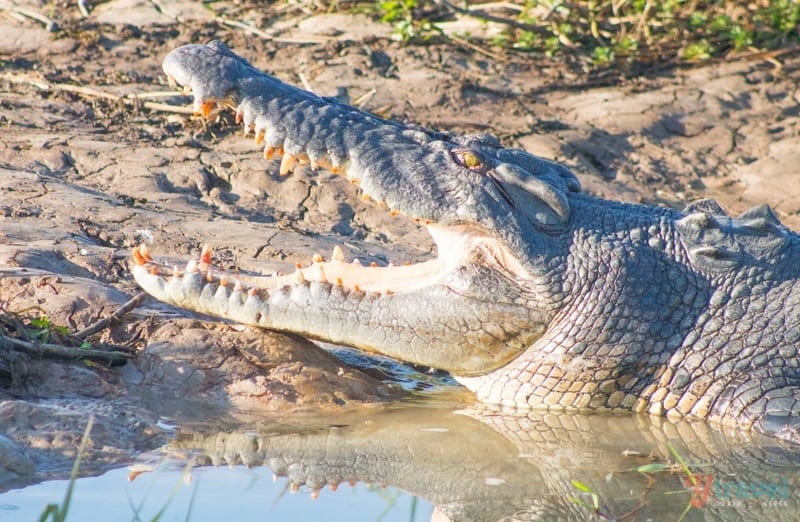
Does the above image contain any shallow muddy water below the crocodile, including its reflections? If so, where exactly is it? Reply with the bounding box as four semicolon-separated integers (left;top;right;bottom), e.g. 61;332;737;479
0;404;800;521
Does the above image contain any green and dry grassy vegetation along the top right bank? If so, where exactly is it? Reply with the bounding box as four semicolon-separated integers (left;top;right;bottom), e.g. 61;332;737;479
354;0;800;68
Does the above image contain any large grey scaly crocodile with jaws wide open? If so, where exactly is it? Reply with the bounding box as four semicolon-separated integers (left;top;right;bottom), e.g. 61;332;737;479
132;41;800;442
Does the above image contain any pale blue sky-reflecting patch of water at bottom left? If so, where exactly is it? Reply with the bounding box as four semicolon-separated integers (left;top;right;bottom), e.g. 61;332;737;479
0;466;433;522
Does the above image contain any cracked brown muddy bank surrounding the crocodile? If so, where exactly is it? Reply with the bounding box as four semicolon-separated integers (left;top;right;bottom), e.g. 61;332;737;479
0;0;800;489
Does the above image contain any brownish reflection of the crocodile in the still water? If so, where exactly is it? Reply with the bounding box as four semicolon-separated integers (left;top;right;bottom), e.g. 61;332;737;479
172;406;800;521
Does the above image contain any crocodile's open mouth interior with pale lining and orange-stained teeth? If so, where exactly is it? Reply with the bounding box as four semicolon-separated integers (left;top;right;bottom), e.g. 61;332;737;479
134;68;526;294
